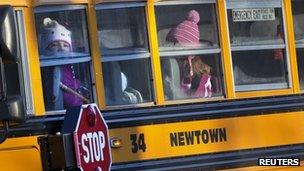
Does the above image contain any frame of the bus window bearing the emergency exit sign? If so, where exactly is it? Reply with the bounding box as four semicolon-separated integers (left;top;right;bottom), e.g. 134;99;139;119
226;0;293;93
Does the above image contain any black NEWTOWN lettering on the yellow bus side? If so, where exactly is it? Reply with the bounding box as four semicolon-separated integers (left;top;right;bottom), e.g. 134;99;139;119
170;128;227;147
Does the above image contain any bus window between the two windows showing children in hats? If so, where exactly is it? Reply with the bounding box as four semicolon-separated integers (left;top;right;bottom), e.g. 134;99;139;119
96;3;153;106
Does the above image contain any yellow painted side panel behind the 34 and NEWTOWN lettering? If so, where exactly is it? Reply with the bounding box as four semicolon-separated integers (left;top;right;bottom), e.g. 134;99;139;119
110;112;304;162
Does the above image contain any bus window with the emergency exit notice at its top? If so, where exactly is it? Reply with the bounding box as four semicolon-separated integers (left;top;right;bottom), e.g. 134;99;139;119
227;0;289;91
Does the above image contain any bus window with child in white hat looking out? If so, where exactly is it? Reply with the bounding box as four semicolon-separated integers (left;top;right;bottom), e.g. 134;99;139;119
35;6;92;111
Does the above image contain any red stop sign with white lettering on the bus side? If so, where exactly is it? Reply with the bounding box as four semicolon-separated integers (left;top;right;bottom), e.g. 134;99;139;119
74;104;112;171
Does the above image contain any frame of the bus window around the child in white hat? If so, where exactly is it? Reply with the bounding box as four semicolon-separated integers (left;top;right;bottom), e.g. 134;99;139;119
33;3;97;115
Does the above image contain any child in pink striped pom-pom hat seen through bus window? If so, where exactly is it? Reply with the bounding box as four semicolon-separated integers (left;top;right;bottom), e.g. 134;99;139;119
166;10;212;97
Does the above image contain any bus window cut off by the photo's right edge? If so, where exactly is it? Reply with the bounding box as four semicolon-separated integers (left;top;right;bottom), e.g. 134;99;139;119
292;0;304;90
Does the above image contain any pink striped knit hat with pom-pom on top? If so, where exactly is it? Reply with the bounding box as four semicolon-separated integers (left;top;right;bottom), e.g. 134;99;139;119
167;10;200;46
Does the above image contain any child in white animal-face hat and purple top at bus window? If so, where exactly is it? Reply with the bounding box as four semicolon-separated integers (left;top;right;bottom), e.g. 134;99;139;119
41;18;89;110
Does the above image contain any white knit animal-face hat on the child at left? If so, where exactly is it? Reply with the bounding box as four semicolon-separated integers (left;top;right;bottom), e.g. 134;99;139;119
41;18;72;51
